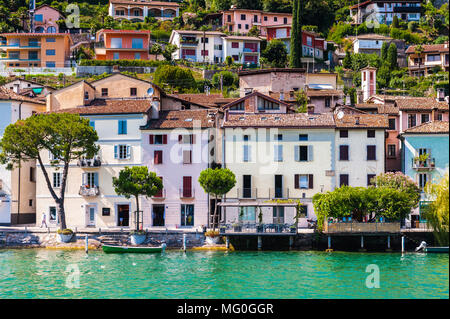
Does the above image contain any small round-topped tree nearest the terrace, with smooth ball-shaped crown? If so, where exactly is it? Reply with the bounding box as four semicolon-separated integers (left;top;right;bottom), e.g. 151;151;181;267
198;168;236;230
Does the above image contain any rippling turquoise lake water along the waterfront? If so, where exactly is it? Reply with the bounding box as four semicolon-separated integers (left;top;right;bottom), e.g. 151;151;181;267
0;249;449;299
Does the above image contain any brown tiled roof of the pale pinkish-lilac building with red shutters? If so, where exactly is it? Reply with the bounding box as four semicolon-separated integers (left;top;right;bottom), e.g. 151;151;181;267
141;110;217;130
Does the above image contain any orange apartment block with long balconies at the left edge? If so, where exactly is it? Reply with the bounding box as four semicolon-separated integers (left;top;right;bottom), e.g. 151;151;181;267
0;33;72;68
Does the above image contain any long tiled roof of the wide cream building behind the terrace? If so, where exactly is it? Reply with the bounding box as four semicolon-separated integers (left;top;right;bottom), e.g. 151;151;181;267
222;113;335;128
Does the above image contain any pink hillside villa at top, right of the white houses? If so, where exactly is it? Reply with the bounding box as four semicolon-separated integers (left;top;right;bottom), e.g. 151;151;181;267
222;8;292;36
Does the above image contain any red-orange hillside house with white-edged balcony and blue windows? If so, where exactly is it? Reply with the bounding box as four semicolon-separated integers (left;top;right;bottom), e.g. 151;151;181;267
95;29;150;60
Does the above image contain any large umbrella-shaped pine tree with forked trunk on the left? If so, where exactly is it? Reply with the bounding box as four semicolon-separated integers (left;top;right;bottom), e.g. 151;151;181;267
0;113;99;230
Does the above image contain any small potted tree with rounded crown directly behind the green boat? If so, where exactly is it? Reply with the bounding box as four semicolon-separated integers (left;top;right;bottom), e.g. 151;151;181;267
113;166;163;231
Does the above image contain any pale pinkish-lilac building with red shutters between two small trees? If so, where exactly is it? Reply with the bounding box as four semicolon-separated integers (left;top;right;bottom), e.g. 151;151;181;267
141;109;217;229
